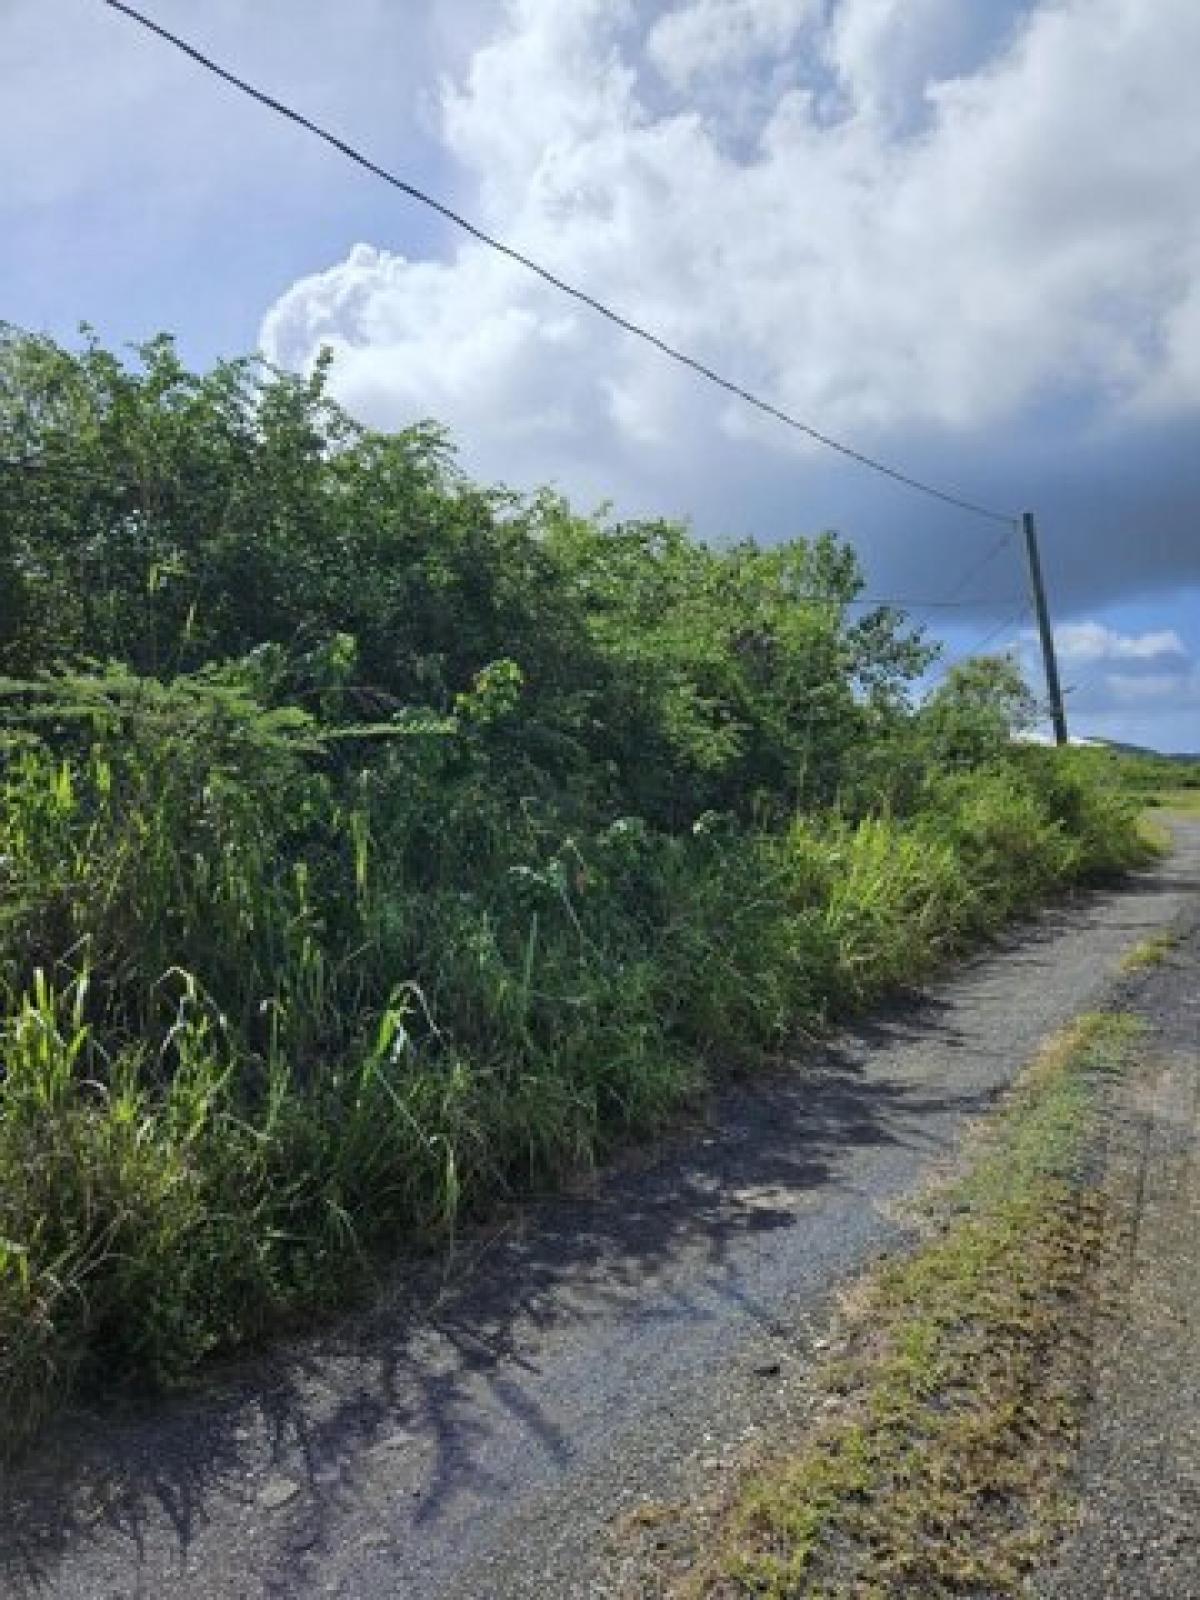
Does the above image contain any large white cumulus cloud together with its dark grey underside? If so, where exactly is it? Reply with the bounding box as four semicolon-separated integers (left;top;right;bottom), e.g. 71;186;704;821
261;0;1200;600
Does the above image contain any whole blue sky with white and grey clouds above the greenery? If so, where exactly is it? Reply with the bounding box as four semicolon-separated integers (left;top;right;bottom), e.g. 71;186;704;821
0;0;1200;750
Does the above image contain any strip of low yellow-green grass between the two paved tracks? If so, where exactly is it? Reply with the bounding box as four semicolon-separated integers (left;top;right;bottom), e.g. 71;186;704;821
690;1014;1138;1600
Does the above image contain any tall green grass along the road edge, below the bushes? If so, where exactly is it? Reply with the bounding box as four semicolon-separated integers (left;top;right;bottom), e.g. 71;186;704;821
0;685;1139;1445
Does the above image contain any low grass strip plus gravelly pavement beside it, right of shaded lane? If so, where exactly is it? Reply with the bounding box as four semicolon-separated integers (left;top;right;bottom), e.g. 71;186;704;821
614;926;1200;1600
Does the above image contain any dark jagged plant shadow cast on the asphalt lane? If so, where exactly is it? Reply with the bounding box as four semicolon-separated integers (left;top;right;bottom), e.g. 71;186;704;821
0;851;1194;1595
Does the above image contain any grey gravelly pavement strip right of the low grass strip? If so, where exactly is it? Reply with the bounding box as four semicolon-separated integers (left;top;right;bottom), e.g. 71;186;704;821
1035;931;1200;1600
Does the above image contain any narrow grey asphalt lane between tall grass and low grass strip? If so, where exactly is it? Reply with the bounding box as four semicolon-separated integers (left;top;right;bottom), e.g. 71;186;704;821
0;822;1200;1600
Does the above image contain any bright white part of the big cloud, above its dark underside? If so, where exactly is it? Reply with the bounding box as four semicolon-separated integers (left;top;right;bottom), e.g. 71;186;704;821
262;0;1200;472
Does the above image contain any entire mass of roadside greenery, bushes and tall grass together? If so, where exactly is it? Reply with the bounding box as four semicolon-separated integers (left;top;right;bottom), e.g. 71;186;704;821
0;330;1146;1443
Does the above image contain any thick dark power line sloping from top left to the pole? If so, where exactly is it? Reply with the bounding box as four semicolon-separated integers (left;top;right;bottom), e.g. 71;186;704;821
104;0;1016;523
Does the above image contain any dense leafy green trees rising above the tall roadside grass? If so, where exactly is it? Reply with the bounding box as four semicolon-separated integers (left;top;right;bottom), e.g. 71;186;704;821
0;328;930;829
